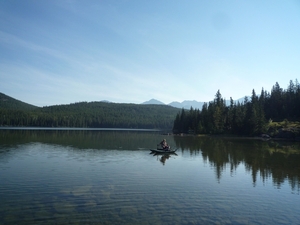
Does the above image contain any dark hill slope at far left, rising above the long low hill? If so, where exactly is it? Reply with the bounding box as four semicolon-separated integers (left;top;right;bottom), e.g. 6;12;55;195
0;92;38;110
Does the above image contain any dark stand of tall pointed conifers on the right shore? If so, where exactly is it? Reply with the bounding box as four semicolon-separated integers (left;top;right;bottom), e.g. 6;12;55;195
173;79;300;135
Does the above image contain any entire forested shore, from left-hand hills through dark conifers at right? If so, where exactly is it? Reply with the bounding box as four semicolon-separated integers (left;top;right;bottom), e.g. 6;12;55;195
0;80;300;135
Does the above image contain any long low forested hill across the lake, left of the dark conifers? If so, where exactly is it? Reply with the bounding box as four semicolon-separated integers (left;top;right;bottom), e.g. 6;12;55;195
0;102;178;130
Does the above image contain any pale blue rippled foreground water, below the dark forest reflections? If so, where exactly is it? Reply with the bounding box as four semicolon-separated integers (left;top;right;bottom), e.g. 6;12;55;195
0;139;300;224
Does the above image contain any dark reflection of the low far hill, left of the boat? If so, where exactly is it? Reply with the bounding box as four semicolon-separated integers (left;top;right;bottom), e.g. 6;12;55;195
0;130;166;150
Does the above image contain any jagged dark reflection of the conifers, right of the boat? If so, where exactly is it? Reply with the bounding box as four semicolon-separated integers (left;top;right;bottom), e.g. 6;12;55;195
174;136;300;190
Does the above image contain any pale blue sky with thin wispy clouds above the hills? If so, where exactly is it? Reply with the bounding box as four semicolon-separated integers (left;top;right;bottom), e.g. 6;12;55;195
0;0;300;106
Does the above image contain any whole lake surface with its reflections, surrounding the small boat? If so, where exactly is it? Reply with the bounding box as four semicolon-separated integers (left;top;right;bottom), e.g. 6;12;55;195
0;130;300;224
